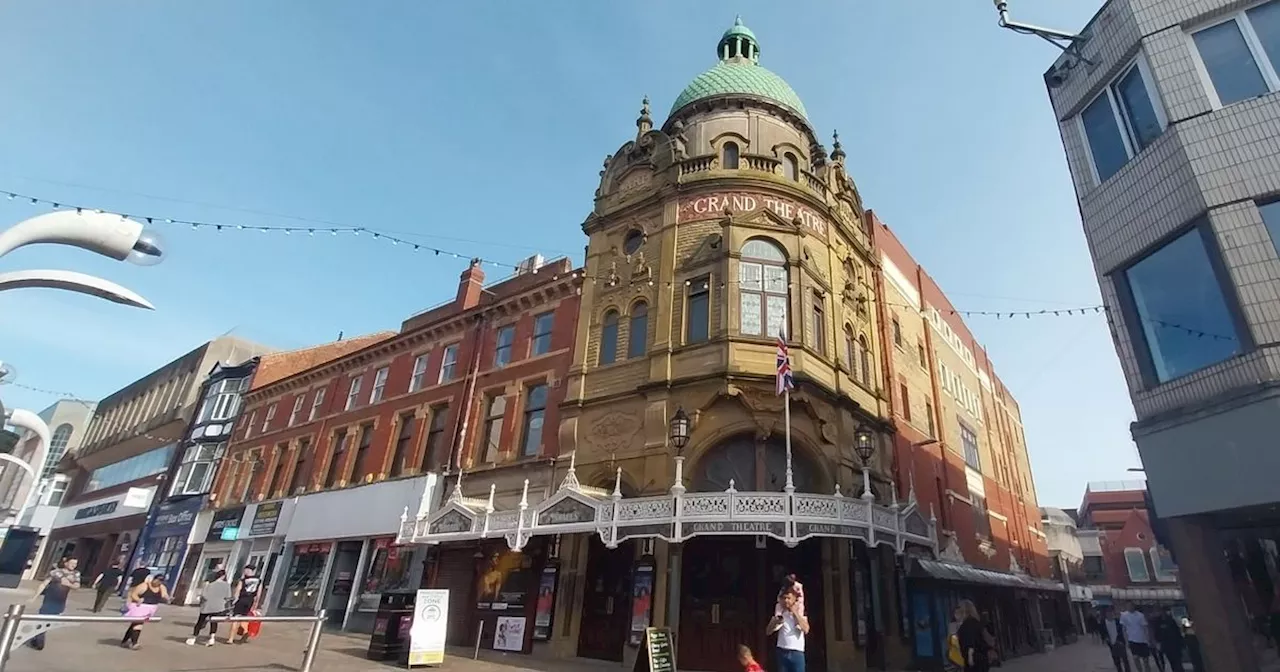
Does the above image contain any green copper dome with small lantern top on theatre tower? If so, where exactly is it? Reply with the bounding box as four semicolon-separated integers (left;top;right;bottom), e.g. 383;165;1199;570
671;18;808;118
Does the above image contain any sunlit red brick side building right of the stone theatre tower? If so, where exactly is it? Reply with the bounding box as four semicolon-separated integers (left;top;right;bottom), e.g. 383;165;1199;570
868;212;1069;657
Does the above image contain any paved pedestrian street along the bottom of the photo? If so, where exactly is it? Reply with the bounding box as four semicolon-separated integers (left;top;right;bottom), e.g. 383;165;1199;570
0;581;1146;672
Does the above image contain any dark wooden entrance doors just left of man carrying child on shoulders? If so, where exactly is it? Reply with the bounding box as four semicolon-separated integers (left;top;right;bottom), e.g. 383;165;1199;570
676;536;757;672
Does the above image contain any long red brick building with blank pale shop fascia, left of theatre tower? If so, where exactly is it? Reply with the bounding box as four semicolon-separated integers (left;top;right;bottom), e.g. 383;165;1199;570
214;257;581;630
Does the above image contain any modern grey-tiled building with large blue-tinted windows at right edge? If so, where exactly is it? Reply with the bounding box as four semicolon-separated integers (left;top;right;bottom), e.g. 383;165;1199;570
1044;0;1280;672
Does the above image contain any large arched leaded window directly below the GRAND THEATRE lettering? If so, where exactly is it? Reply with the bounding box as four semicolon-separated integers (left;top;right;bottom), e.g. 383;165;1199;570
737;238;787;337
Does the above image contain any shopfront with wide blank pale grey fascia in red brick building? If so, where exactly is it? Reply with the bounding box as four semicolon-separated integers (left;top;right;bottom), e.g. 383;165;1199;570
274;474;436;632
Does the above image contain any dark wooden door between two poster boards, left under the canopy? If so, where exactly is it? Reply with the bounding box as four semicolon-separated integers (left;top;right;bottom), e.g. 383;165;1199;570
577;534;635;663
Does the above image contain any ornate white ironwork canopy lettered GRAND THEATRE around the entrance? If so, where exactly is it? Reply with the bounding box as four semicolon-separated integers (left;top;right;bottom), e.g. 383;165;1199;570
397;453;937;553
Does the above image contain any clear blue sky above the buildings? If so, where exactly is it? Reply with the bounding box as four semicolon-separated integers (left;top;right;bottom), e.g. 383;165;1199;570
0;0;1138;506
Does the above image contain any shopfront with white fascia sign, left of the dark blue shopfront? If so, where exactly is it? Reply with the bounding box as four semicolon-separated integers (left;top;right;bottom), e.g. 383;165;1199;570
42;485;156;581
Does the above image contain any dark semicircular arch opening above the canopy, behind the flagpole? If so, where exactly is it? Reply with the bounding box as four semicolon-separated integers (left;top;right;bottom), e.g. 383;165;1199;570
690;434;829;493
